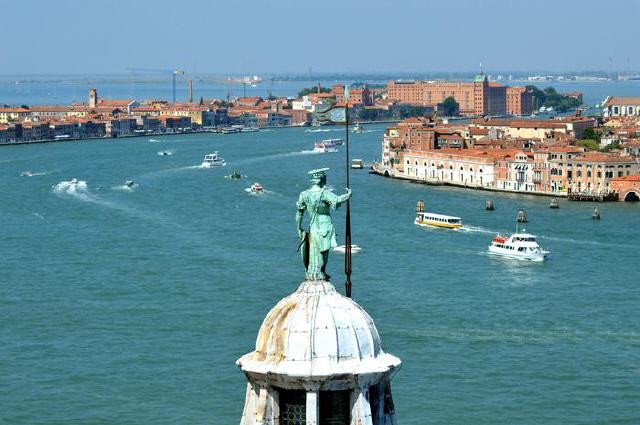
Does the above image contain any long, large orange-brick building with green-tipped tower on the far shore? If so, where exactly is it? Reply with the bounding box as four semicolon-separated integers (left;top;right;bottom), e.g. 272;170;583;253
387;75;507;116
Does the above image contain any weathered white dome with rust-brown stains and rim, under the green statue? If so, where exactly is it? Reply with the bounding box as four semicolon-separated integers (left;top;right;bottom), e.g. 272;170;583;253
237;281;401;378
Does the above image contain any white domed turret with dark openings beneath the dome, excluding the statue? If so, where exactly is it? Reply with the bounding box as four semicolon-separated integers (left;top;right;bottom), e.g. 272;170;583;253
236;280;401;425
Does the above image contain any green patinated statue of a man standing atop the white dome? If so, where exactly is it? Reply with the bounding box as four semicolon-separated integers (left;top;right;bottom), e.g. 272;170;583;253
296;168;351;280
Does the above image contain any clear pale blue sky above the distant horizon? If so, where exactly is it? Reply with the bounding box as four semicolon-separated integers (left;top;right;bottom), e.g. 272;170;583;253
0;0;640;74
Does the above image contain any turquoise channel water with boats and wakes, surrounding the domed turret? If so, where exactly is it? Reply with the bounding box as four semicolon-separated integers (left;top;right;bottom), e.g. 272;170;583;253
0;126;640;425
